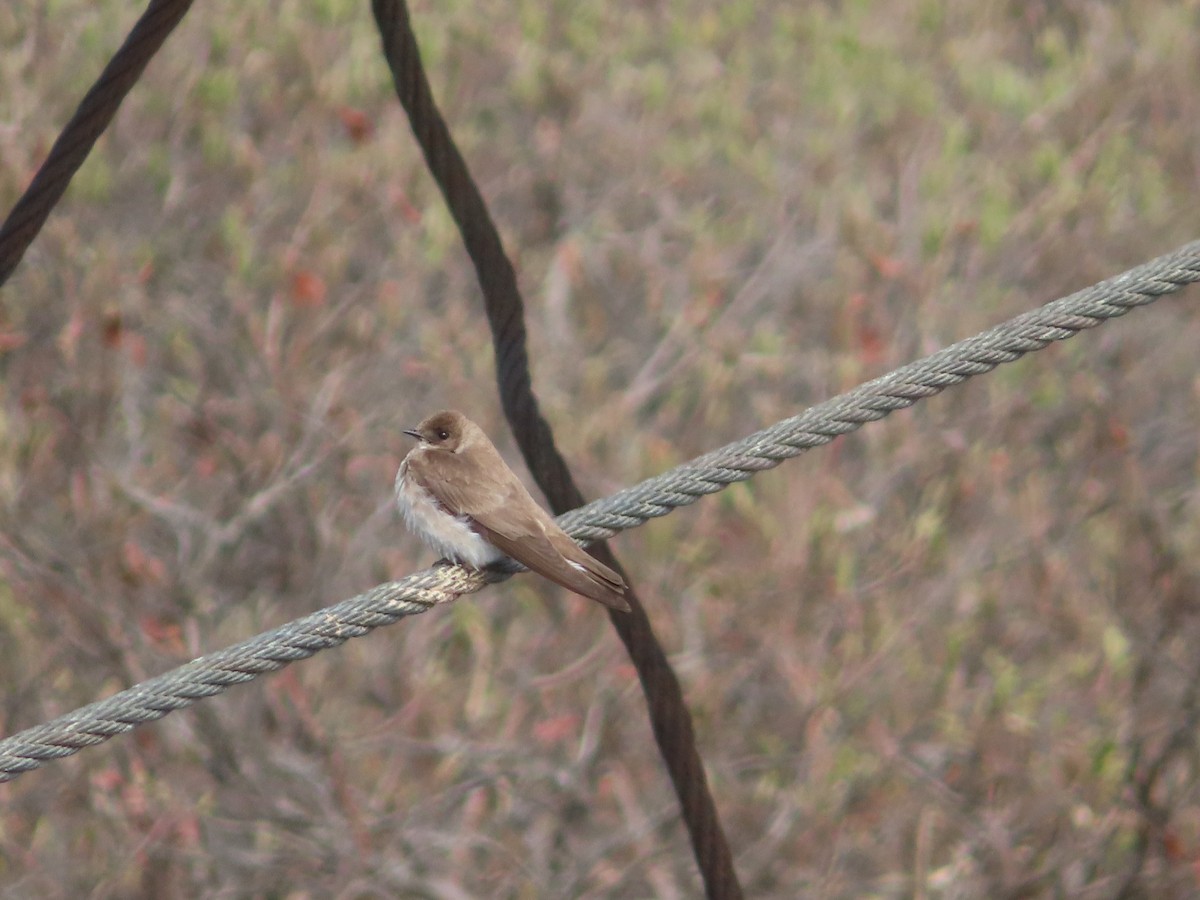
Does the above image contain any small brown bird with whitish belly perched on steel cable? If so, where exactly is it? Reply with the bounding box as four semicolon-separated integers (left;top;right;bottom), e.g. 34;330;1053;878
396;409;629;612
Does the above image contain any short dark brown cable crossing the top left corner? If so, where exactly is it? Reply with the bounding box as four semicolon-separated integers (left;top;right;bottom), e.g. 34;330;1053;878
0;0;192;284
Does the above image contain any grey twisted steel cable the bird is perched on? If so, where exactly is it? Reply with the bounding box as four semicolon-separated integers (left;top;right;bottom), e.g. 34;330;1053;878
0;241;1200;781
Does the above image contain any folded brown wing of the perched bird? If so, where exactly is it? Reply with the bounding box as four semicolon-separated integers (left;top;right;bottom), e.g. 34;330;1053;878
425;455;629;612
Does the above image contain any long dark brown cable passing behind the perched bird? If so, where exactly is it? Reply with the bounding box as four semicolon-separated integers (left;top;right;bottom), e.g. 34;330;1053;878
371;0;742;900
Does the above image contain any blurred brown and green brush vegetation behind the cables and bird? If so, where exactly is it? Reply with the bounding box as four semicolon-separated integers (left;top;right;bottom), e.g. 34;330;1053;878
0;0;1200;899
